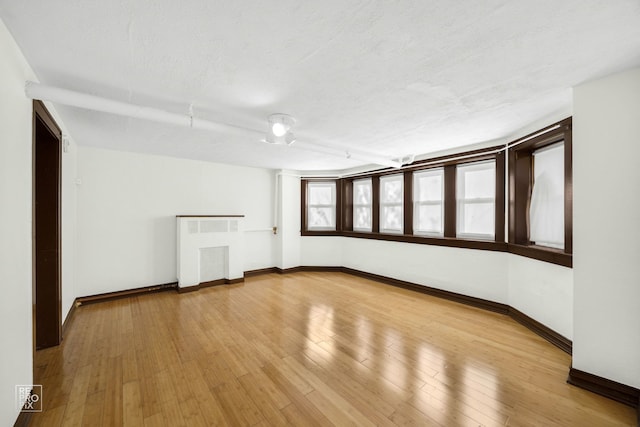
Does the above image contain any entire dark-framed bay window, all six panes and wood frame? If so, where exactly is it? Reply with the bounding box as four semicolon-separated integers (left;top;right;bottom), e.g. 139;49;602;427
301;118;572;267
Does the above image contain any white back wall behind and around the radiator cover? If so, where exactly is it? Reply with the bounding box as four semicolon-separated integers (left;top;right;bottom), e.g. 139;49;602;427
76;146;275;296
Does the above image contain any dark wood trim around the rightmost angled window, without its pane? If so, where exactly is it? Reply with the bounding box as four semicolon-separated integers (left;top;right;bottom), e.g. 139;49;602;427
508;118;573;267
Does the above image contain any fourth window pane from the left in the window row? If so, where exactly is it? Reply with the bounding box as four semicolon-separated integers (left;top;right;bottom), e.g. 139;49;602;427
413;168;444;236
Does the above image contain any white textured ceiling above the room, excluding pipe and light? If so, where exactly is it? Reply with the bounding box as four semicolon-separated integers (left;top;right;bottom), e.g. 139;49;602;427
0;0;640;170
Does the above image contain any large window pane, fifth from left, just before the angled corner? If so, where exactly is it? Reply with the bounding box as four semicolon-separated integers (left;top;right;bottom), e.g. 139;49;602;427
456;160;496;239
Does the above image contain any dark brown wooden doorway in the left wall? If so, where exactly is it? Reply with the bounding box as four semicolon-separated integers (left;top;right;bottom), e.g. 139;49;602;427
33;101;62;350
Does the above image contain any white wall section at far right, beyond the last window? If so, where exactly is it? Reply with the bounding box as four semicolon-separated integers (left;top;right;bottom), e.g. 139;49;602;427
573;69;640;388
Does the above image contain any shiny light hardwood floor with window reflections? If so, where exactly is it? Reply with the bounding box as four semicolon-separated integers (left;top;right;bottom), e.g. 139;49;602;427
31;273;636;427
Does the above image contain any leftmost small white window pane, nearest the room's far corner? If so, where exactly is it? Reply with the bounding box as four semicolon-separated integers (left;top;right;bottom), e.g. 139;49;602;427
307;181;336;231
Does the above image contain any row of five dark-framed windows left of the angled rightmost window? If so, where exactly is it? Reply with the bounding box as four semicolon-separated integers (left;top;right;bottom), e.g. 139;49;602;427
300;145;509;251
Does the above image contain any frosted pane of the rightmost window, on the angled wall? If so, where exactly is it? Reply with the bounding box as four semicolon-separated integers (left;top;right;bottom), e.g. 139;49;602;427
529;144;564;249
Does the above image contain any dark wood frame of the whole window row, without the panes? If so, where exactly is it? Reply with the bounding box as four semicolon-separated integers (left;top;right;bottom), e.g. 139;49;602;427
301;117;573;268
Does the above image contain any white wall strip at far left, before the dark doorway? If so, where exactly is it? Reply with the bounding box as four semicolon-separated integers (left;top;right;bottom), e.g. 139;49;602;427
0;16;33;425
